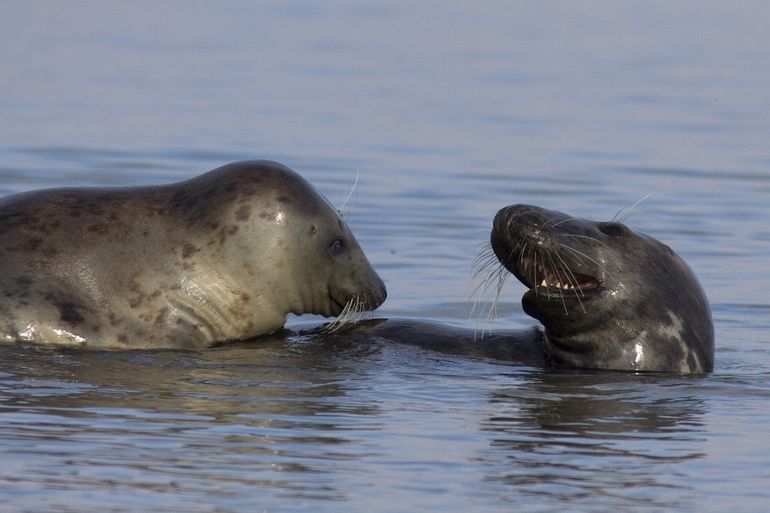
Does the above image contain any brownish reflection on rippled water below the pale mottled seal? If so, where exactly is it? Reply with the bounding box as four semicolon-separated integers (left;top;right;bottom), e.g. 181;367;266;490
0;341;388;506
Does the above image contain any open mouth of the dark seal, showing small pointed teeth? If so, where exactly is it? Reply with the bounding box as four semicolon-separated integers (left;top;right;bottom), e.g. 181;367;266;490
514;257;601;297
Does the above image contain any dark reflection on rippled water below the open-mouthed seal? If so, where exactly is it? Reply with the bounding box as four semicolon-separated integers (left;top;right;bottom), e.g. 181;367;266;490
481;372;705;511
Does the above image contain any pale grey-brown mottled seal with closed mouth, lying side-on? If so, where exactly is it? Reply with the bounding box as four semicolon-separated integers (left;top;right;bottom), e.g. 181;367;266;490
0;161;385;348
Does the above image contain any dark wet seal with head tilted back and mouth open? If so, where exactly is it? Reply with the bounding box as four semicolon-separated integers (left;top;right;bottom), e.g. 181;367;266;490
316;205;714;374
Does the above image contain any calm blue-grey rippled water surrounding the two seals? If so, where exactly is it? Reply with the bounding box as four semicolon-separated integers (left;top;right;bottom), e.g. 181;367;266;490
0;0;770;513
